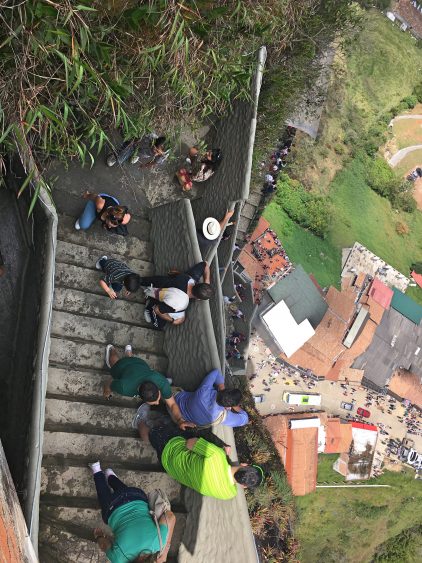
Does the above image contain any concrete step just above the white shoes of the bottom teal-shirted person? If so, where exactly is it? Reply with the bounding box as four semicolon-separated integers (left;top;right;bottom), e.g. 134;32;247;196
43;430;158;468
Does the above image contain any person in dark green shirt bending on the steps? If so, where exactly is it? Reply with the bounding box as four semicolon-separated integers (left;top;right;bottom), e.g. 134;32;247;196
103;344;195;430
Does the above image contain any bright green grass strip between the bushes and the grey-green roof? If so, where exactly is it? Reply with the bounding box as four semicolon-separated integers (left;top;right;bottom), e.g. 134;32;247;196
264;202;341;287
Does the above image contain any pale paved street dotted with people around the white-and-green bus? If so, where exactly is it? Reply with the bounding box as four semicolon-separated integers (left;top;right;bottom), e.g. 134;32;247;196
248;335;422;476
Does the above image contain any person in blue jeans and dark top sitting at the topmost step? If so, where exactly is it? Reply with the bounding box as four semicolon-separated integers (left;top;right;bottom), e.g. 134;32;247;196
75;191;131;236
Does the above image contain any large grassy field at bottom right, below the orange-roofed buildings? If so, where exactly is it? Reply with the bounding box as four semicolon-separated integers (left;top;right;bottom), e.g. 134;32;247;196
296;472;422;563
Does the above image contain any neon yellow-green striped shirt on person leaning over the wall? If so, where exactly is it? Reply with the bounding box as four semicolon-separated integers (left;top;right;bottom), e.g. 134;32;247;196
161;436;237;500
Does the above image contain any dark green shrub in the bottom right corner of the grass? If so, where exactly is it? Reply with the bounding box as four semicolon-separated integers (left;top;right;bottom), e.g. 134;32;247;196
371;525;422;563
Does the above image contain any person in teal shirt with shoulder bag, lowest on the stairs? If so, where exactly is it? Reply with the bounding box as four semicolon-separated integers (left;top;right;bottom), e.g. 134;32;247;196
90;461;176;563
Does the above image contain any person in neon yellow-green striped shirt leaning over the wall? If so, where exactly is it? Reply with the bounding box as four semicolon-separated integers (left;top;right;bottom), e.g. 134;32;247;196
138;420;264;500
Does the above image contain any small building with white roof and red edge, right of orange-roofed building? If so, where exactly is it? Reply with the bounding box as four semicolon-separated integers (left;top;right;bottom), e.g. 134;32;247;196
333;422;378;481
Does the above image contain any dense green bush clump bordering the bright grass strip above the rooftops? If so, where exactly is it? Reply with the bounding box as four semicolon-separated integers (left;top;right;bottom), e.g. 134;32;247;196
275;174;331;238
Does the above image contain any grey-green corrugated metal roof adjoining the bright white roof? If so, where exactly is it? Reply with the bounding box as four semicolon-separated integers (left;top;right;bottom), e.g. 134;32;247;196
268;264;328;328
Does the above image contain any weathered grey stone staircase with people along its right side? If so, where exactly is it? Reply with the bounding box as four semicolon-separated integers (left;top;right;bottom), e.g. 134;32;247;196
39;215;186;563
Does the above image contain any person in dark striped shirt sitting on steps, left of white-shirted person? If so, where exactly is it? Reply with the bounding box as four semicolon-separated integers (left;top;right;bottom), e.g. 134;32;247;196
95;256;140;299
